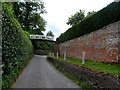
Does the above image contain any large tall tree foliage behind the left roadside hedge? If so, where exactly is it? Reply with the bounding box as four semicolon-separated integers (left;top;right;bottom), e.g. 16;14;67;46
13;0;46;35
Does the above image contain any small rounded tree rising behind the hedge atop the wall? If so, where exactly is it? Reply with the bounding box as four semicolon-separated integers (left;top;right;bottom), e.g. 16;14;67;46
67;10;85;26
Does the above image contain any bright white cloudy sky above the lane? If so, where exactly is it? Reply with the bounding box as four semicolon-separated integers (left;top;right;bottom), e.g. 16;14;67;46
42;0;114;40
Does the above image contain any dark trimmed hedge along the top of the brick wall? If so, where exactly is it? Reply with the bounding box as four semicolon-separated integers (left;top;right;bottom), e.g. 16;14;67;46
57;2;120;43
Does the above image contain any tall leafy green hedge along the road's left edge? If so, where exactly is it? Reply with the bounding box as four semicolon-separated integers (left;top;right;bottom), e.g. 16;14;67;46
2;3;33;90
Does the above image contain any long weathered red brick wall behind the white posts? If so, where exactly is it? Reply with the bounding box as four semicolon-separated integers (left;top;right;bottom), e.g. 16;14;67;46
55;21;120;62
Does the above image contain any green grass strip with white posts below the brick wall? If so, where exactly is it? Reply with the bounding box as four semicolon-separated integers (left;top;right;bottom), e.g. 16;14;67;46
48;57;120;76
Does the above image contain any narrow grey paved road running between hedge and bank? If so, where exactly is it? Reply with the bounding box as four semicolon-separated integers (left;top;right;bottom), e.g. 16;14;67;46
12;55;80;88
